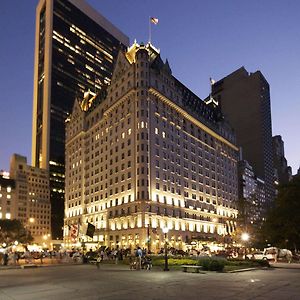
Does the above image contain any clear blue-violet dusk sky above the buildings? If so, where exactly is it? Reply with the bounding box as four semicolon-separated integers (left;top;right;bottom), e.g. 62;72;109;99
0;0;300;173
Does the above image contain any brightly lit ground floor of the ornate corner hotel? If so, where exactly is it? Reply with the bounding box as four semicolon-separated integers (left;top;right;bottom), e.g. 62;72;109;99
63;218;236;253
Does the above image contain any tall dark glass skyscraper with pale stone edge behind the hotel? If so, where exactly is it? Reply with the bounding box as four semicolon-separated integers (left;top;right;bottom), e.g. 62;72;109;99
32;0;129;238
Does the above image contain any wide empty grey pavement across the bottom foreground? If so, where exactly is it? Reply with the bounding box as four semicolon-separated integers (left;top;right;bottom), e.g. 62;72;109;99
0;265;300;300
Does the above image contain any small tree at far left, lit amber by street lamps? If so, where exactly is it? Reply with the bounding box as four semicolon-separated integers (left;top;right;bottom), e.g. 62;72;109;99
0;220;33;246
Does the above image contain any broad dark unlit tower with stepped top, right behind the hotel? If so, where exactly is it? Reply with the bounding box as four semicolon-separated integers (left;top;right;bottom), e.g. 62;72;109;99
212;67;275;207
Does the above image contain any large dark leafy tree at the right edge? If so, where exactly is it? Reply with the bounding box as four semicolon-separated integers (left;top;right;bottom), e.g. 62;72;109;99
262;176;300;249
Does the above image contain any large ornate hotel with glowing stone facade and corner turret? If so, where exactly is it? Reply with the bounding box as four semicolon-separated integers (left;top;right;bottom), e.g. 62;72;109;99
64;43;238;252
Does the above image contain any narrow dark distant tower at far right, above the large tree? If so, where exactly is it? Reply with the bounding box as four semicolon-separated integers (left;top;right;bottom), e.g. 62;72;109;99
273;135;292;184
